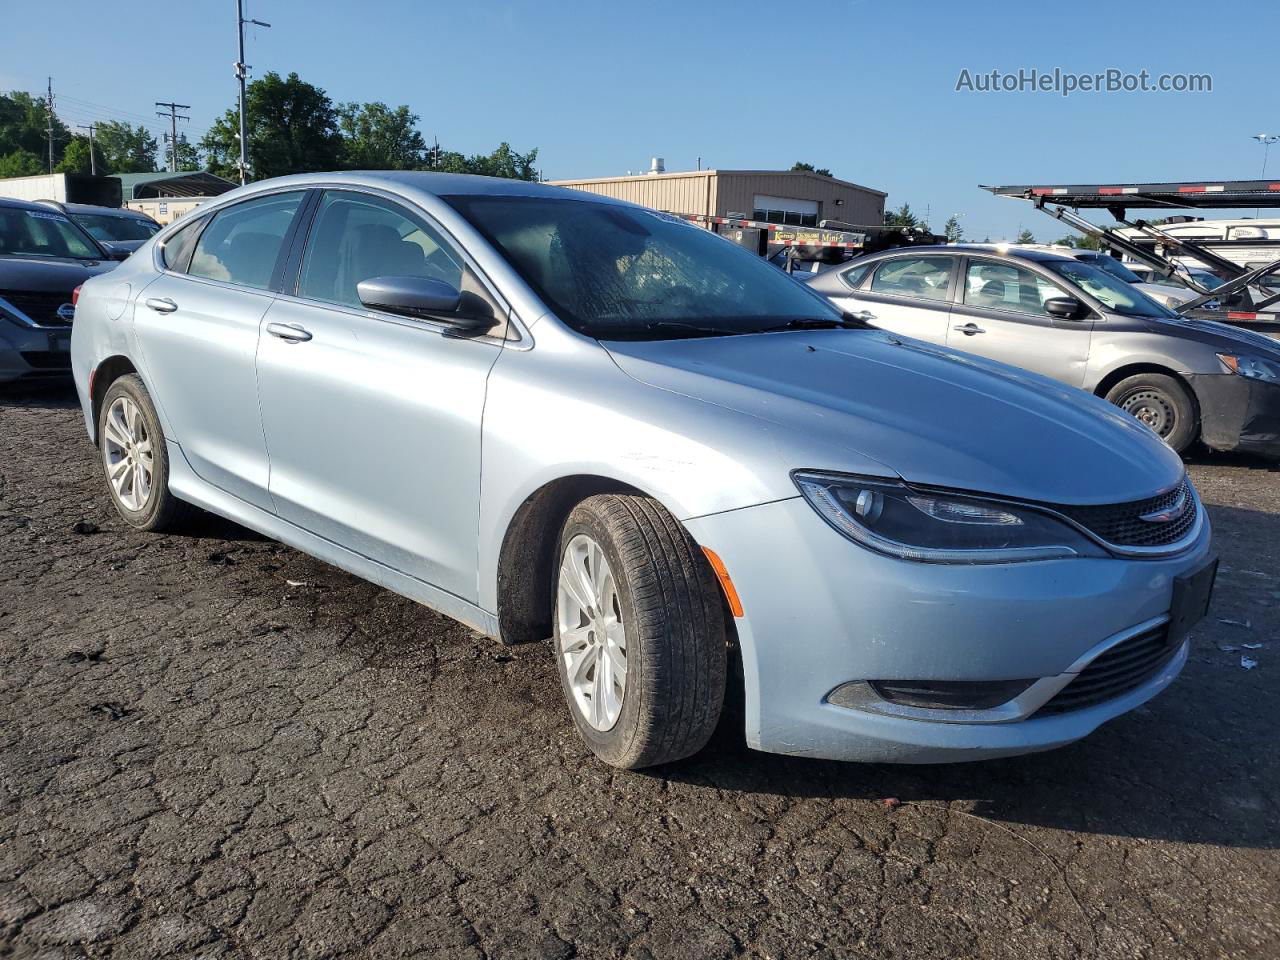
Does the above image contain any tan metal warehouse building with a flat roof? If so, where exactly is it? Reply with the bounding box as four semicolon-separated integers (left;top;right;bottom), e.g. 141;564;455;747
552;168;887;227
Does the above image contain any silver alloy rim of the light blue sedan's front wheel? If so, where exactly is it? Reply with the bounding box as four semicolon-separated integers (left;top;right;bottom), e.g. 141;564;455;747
556;534;627;731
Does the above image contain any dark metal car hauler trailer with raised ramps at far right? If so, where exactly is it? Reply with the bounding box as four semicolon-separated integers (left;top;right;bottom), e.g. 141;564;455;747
983;180;1280;337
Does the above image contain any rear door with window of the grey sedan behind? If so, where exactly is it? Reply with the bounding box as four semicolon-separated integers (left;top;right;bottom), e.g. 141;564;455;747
827;253;956;343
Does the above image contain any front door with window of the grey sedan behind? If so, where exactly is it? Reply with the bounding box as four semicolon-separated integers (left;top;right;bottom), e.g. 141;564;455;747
947;257;1096;387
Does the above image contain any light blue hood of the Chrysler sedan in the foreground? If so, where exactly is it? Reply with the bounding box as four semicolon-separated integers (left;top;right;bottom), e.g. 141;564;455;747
604;330;1184;504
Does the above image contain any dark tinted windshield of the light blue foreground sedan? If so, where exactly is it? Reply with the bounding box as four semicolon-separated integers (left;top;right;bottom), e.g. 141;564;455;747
444;196;841;339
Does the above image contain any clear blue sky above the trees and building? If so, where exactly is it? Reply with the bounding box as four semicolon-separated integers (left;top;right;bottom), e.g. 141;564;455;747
0;0;1280;239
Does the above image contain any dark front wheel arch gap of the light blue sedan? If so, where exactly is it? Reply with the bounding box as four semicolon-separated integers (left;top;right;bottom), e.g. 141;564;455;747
497;474;650;644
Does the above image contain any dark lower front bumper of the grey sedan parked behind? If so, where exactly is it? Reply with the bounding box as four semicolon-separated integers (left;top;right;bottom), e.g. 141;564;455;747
1187;374;1280;458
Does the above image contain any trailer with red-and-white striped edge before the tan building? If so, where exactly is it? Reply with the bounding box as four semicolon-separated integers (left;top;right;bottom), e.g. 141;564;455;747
675;212;946;273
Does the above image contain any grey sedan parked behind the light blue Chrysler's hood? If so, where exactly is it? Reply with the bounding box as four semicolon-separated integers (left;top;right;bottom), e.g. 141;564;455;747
809;243;1280;457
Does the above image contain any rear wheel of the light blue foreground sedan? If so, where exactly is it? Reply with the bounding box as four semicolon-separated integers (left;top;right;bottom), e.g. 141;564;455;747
97;374;196;532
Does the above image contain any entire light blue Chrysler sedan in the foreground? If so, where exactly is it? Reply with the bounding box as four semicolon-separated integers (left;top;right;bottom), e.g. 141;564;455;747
72;173;1215;767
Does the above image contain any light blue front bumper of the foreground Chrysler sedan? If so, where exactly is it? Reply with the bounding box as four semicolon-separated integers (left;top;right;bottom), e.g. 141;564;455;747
686;498;1211;763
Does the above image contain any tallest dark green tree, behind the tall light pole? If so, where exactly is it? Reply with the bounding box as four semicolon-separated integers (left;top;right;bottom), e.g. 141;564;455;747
200;72;343;179
